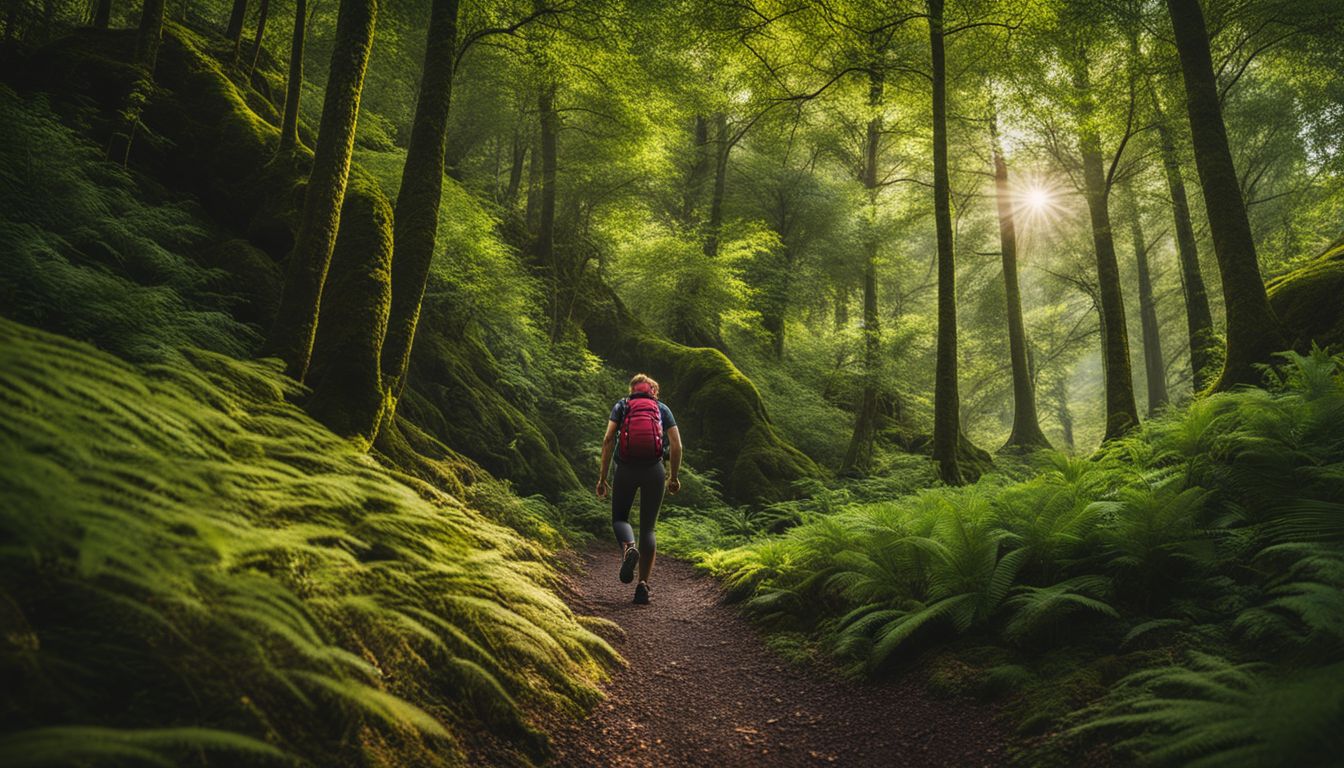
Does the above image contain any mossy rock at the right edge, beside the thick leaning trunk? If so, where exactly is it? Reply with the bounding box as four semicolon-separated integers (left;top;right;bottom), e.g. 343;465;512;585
1267;241;1344;351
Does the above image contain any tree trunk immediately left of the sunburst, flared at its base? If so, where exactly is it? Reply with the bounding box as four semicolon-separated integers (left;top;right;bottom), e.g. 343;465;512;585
989;116;1050;451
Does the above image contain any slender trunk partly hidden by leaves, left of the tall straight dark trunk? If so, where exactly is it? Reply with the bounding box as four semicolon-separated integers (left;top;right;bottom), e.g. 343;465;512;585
837;63;883;473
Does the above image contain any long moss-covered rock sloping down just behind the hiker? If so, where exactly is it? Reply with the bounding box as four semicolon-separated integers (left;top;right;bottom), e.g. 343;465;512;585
578;277;821;503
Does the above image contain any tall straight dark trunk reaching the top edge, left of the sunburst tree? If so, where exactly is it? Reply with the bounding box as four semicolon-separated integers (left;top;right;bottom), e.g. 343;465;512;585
929;0;988;486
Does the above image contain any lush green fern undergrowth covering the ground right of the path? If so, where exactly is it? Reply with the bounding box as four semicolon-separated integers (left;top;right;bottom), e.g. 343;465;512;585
688;350;1344;765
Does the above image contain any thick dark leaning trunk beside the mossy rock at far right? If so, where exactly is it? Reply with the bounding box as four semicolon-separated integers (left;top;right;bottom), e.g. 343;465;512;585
1167;0;1288;390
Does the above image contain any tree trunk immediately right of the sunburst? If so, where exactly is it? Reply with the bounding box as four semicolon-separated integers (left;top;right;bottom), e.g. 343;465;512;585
1074;62;1138;440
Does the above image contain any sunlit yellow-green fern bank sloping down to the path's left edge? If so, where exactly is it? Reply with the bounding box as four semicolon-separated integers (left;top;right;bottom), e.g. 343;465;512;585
0;321;614;765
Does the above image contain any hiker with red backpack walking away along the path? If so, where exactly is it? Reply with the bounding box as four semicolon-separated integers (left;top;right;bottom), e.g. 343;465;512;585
597;374;681;605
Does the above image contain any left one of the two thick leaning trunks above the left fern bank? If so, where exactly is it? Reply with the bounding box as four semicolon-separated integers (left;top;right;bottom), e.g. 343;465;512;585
269;0;378;381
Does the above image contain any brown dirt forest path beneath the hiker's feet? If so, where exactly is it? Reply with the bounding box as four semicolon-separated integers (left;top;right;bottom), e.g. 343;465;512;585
547;545;1004;768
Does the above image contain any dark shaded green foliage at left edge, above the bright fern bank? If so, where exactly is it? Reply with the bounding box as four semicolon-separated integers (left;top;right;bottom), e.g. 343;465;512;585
0;86;257;360
